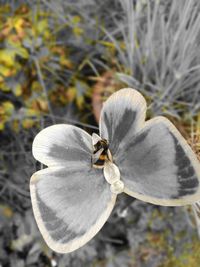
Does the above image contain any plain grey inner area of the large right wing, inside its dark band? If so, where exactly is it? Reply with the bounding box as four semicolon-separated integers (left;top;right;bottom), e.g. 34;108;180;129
116;123;177;198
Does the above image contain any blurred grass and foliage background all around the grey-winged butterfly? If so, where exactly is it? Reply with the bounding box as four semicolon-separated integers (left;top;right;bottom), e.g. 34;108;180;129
0;0;200;267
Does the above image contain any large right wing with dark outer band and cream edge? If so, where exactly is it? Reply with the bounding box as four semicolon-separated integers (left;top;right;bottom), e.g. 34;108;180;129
114;117;200;206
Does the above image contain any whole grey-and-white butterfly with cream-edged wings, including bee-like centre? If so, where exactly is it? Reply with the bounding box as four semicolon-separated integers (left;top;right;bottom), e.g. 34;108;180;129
30;88;200;253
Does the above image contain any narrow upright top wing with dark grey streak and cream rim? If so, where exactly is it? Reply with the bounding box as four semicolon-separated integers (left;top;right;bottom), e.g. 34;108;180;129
99;88;147;155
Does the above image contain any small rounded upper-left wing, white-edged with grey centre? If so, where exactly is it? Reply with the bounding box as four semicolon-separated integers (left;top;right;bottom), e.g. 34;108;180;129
32;124;92;167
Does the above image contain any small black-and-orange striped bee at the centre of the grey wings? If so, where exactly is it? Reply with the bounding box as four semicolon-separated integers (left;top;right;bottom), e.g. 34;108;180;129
92;133;112;169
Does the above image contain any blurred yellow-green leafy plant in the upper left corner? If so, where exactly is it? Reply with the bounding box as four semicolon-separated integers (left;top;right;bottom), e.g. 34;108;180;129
0;4;91;130
